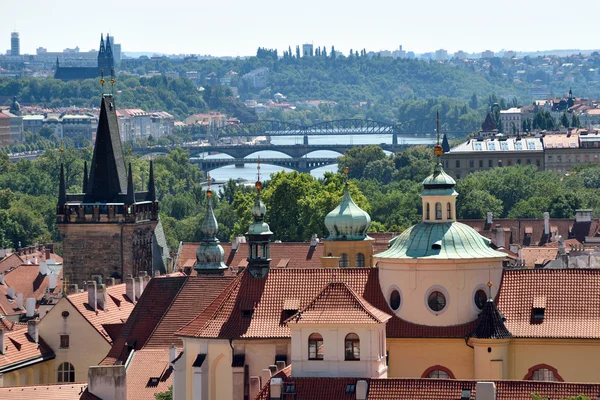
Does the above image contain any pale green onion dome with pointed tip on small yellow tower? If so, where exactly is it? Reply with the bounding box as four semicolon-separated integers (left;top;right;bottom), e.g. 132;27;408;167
325;184;371;240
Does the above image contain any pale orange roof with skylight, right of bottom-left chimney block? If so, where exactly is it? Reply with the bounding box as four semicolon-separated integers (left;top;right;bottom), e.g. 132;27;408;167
127;348;173;400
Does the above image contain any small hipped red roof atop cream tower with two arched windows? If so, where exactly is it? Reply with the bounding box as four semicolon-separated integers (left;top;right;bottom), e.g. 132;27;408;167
286;282;391;324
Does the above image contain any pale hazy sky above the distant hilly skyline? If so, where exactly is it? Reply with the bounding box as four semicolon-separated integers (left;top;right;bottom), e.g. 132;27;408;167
0;0;600;56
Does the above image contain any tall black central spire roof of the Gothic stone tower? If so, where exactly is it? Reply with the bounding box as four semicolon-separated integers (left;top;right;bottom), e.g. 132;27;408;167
85;95;127;203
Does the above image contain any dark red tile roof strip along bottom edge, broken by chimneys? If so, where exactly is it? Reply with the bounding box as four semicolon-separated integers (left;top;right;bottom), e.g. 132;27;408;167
256;372;600;400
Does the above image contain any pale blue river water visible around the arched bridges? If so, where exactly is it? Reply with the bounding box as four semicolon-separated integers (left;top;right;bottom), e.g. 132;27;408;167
197;135;435;182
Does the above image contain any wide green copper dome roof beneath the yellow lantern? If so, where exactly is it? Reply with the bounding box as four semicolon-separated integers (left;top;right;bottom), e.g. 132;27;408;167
373;222;506;260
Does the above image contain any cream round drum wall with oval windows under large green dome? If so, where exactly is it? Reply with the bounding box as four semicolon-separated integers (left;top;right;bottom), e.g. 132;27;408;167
378;259;502;326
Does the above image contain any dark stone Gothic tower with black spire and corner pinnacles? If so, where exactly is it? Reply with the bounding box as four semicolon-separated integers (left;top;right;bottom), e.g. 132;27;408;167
56;95;158;284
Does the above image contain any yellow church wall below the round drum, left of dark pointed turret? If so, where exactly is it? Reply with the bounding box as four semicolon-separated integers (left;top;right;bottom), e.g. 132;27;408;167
387;338;474;379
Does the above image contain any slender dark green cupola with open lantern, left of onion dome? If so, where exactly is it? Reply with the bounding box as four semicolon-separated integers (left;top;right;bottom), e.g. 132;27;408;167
246;162;273;278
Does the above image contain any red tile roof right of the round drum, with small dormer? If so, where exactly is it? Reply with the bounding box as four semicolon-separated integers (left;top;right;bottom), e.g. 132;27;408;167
497;269;600;339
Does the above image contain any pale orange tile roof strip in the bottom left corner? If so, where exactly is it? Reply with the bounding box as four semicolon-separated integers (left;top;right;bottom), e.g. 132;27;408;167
0;382;92;400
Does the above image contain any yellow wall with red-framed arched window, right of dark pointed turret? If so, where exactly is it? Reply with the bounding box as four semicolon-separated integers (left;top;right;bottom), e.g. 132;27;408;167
508;339;600;382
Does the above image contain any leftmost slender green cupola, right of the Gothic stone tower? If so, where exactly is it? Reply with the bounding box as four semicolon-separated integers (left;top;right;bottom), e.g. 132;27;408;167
194;185;227;274
